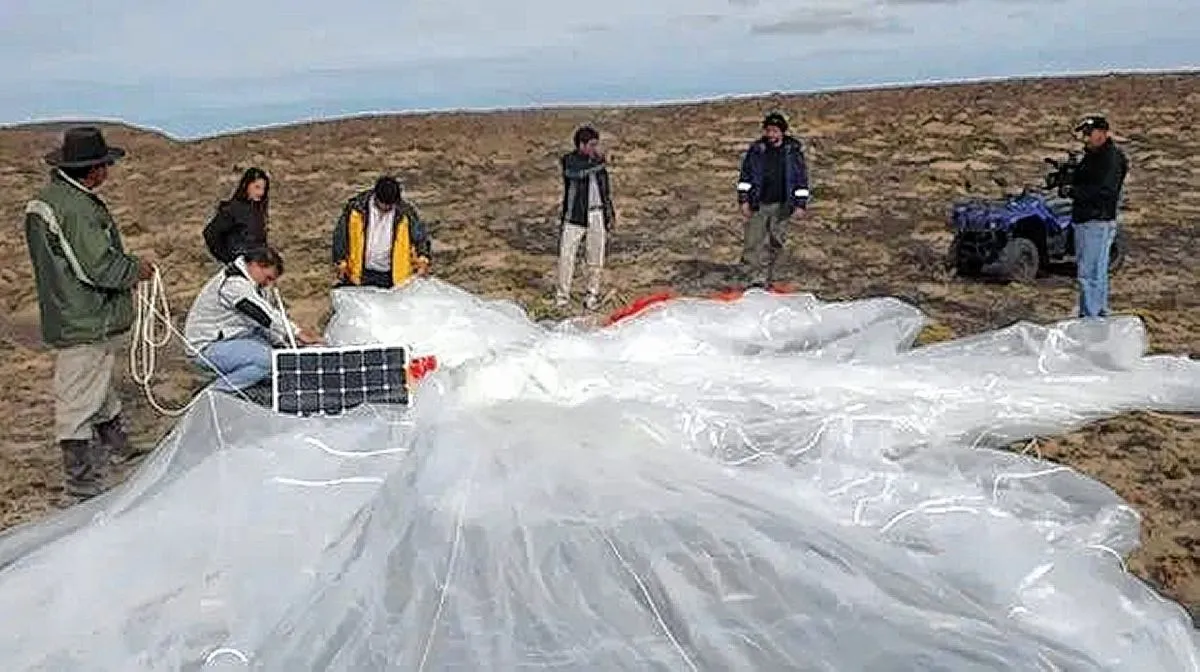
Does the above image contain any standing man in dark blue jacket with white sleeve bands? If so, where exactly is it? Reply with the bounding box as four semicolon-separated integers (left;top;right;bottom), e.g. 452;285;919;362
738;113;809;288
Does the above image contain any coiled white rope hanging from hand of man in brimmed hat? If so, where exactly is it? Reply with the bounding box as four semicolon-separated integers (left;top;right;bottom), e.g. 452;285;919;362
130;266;253;418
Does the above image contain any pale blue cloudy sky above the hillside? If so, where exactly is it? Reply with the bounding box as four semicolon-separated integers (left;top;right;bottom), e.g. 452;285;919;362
0;0;1200;137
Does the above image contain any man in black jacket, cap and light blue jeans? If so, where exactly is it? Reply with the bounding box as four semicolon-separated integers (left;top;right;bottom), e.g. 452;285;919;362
1070;115;1129;317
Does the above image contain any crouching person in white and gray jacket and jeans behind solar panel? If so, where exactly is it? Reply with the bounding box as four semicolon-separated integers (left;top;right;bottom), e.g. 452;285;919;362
184;247;322;392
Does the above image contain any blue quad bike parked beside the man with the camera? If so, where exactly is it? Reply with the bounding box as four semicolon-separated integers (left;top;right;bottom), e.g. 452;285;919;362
947;152;1126;282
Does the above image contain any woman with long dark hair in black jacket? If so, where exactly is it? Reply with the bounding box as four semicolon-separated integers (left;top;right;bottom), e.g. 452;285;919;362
204;168;271;264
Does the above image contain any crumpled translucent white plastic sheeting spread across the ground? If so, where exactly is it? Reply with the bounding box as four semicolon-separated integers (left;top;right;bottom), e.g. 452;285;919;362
0;280;1200;672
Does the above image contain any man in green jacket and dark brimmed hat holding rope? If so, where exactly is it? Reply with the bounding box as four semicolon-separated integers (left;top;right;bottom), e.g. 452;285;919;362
25;127;154;499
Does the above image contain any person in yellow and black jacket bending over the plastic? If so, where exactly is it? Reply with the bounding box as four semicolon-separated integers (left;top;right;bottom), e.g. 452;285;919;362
334;175;431;288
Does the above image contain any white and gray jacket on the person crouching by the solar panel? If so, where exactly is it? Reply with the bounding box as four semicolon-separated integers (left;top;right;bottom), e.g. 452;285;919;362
184;257;300;354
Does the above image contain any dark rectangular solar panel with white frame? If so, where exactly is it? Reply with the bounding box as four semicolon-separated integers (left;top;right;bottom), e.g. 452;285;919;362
271;346;408;415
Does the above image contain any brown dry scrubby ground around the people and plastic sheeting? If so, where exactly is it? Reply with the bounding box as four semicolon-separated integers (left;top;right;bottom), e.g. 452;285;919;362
0;73;1200;612
